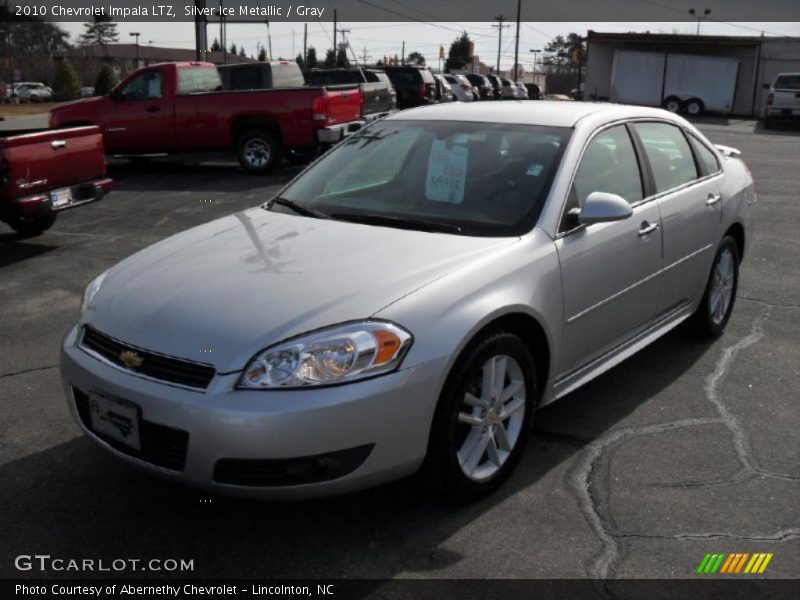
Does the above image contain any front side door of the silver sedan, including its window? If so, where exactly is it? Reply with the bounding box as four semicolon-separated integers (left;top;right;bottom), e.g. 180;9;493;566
555;124;662;377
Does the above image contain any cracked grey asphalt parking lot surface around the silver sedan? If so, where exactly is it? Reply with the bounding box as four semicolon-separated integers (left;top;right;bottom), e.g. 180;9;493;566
0;119;800;578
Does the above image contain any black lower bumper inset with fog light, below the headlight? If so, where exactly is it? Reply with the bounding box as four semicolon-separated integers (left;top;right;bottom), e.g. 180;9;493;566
214;444;375;487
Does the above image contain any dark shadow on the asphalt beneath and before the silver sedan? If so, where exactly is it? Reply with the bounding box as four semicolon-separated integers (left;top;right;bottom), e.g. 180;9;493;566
0;327;711;586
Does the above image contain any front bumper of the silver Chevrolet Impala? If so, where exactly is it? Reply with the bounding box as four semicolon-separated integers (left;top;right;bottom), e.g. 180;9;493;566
61;328;447;499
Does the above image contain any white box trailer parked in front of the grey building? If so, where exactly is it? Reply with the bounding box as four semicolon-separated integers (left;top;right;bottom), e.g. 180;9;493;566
611;50;739;115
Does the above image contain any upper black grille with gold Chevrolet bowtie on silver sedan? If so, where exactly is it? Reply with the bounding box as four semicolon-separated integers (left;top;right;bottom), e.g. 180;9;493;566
81;325;216;390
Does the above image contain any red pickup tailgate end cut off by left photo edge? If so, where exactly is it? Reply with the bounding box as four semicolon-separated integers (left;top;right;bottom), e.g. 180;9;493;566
0;127;112;236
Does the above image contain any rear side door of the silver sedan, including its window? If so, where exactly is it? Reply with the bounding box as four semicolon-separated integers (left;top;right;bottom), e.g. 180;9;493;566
632;122;722;311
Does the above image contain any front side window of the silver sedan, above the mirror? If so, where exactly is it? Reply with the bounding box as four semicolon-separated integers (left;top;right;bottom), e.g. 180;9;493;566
567;125;643;210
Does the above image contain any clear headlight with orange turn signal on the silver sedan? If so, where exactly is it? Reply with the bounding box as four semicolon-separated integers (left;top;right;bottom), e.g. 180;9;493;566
236;321;412;390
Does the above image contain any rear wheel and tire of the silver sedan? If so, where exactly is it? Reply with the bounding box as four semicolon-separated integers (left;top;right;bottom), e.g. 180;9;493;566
693;236;740;337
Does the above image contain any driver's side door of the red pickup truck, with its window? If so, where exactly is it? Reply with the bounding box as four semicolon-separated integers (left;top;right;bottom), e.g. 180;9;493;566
104;68;174;154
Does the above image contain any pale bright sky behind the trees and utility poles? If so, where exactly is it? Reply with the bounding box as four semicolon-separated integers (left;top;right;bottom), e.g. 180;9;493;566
60;20;800;70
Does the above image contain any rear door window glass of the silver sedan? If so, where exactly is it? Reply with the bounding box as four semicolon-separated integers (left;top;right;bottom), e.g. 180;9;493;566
634;123;697;192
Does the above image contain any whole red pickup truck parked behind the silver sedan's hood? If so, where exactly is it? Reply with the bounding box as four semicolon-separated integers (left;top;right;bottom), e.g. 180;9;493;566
50;62;364;173
